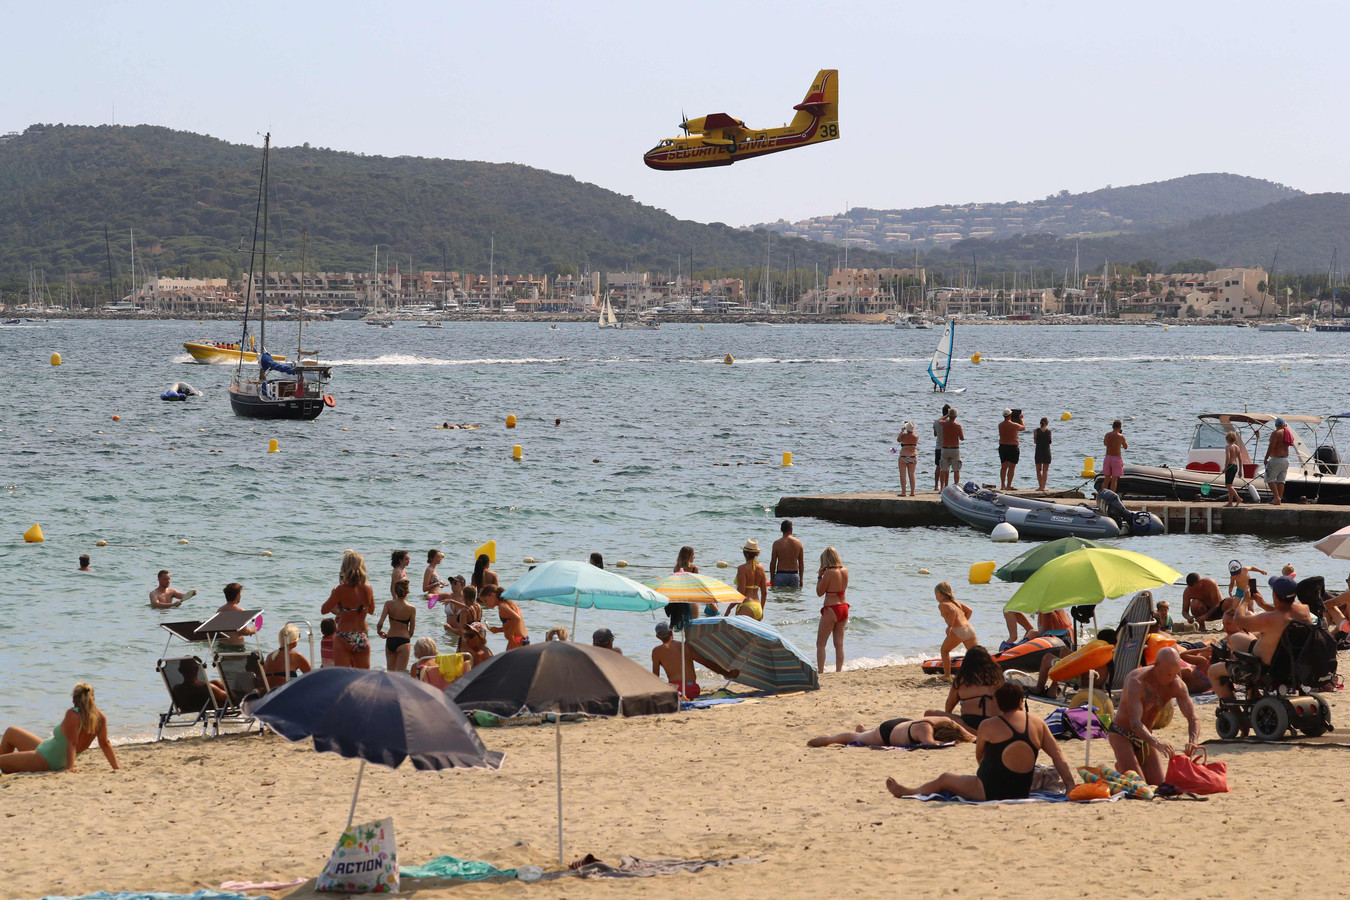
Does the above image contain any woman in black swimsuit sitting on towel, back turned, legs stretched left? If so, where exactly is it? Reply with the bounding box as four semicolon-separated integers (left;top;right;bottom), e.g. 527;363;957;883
886;682;1075;800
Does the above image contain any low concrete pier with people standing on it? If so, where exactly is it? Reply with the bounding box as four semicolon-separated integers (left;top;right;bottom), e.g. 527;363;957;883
776;491;1350;540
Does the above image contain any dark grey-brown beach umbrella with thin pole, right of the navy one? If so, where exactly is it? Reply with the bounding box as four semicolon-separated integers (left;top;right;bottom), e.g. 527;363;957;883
447;644;679;865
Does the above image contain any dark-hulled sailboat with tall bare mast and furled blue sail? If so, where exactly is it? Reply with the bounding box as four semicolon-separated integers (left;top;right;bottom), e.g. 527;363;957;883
230;134;333;420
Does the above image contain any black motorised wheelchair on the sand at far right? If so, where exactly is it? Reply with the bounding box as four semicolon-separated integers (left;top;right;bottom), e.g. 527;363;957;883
1215;622;1341;741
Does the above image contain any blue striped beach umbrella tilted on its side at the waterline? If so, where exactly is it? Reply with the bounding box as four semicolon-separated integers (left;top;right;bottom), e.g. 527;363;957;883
684;615;821;691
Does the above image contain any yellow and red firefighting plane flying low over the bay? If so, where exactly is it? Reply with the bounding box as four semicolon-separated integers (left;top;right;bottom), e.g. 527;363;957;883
643;69;840;171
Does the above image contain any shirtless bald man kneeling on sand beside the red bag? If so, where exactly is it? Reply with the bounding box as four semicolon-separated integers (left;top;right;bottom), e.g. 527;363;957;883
1107;646;1200;785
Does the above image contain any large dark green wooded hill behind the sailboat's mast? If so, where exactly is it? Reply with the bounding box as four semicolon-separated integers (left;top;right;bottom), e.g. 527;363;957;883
0;125;884;283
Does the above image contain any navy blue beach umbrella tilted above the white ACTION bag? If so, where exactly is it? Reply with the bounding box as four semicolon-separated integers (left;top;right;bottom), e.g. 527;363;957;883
243;667;502;827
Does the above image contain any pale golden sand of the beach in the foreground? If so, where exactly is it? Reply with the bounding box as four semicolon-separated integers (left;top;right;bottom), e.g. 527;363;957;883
0;654;1350;900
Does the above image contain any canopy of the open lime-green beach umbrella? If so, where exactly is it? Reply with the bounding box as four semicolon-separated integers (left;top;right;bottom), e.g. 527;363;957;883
1003;546;1181;613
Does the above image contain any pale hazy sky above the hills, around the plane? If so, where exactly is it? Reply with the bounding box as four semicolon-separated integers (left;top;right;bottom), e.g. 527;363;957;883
0;0;1350;224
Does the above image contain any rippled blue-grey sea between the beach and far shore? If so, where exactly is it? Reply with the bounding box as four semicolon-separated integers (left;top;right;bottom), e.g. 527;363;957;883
0;322;1350;737
